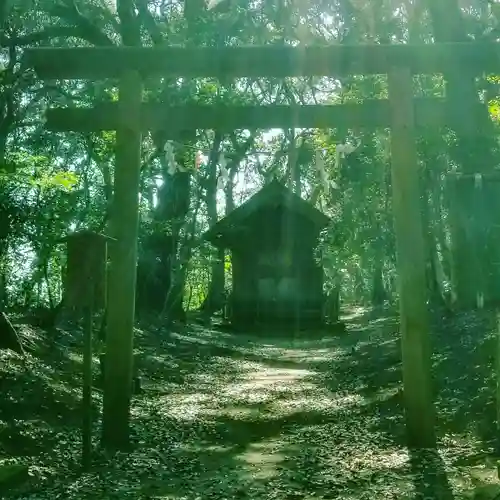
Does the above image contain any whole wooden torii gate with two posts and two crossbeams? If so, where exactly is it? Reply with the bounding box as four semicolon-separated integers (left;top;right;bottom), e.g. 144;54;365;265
24;43;500;447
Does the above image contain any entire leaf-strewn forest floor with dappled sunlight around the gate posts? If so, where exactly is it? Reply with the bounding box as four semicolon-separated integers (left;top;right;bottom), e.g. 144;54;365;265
0;310;496;500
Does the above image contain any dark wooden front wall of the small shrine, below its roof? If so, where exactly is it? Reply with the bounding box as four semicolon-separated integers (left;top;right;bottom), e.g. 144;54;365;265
232;208;323;326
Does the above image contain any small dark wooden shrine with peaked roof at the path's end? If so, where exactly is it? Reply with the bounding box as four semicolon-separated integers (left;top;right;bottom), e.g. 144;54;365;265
205;181;329;328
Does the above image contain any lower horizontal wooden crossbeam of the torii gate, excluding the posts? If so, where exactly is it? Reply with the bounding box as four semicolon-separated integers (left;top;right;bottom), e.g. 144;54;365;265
46;98;476;134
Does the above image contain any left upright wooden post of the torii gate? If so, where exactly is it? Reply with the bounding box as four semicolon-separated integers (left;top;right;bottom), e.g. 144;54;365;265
102;72;142;449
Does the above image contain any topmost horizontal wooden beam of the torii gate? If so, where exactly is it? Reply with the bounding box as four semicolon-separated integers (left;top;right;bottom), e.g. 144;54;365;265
23;42;500;79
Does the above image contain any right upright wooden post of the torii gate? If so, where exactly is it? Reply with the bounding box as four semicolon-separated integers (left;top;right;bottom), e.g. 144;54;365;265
388;67;436;448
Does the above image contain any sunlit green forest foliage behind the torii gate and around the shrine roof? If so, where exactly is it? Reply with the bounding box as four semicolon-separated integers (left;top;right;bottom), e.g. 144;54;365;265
0;0;500;310
